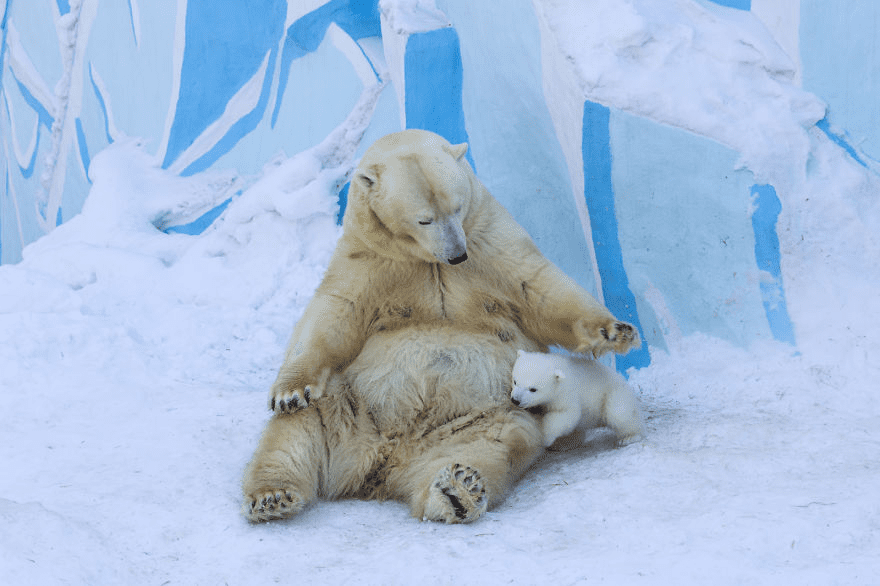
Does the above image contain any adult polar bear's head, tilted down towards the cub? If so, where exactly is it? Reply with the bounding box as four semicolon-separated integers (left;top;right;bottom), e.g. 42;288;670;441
344;130;475;265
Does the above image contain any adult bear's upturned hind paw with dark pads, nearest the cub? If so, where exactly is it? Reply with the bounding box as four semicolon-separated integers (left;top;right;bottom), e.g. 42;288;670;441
424;464;489;523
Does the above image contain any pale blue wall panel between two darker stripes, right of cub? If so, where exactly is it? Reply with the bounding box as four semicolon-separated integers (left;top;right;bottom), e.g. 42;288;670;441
610;110;773;348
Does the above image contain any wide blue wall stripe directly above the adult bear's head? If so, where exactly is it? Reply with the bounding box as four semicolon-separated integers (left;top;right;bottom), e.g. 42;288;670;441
404;27;476;168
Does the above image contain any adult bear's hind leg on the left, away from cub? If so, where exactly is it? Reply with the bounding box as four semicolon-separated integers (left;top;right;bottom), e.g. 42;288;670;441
242;408;327;522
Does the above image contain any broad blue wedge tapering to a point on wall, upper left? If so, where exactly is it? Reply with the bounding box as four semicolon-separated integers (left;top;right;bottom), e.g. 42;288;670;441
162;0;287;172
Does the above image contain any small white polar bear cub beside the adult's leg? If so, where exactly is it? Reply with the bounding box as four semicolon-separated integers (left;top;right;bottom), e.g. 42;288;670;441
510;350;645;447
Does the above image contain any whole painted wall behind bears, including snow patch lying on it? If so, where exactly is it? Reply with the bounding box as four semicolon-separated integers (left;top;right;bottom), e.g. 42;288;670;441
0;0;880;370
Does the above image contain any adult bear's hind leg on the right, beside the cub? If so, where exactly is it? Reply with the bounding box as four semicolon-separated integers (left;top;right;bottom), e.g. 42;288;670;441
387;410;542;523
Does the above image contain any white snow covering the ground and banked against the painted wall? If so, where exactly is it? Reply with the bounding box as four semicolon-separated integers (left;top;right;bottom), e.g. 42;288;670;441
0;0;880;584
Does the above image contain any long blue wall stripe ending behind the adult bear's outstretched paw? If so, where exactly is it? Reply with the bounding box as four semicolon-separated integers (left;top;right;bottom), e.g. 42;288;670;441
581;101;651;373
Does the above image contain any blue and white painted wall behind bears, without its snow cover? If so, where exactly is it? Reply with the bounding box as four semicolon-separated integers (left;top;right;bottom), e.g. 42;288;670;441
0;0;880;370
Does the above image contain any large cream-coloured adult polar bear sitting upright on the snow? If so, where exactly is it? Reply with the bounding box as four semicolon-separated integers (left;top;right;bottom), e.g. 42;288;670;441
242;130;639;523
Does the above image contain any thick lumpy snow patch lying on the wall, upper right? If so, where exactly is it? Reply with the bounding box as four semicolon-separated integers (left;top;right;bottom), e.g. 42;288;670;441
535;0;825;180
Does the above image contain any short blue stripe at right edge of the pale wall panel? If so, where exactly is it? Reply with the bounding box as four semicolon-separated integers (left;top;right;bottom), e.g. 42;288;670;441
751;185;795;346
